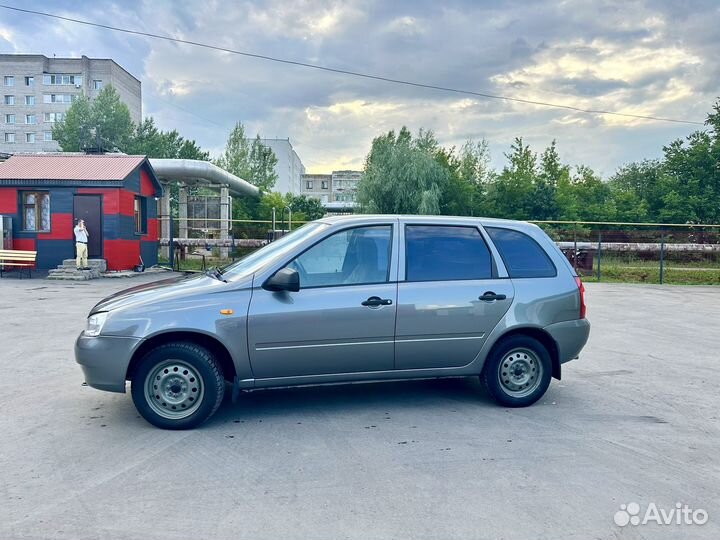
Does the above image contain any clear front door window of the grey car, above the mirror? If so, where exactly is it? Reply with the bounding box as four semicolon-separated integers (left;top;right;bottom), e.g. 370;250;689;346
287;225;392;289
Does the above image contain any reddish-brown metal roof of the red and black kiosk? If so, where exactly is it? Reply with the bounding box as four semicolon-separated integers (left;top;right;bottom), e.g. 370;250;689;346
0;154;146;182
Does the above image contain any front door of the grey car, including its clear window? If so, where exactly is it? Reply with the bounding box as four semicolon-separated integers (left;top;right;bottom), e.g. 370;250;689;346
248;223;397;379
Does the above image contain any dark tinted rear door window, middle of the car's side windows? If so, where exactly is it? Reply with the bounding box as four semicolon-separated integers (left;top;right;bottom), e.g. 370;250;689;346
405;225;492;281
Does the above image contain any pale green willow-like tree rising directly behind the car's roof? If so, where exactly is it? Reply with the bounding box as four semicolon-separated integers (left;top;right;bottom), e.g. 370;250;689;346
357;126;449;214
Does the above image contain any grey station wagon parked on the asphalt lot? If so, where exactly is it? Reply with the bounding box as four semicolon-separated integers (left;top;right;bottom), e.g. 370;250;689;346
75;215;590;429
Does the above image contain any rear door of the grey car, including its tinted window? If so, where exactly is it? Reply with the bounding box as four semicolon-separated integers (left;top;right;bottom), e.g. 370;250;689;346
395;221;514;369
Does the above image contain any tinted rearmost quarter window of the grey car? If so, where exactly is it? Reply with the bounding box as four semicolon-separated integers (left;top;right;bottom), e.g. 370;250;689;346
485;227;557;278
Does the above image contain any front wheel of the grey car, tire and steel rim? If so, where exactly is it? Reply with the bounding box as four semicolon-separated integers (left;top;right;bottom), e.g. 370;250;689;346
131;342;225;429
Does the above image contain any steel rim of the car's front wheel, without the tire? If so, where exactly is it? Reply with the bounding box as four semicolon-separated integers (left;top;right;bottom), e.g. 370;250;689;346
145;360;205;420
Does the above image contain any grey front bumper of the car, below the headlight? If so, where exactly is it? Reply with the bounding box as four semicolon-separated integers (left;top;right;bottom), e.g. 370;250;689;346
75;334;142;392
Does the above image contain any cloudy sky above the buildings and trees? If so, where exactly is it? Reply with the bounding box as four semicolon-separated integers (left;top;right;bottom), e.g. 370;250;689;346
0;0;720;176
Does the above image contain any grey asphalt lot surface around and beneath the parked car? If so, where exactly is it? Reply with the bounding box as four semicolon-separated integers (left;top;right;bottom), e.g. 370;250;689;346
0;276;720;540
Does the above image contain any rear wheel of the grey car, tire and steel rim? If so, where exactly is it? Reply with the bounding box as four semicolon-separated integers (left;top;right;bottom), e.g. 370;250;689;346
480;335;552;407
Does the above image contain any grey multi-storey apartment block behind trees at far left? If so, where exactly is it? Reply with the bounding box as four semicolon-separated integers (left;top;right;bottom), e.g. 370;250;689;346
0;54;142;153
